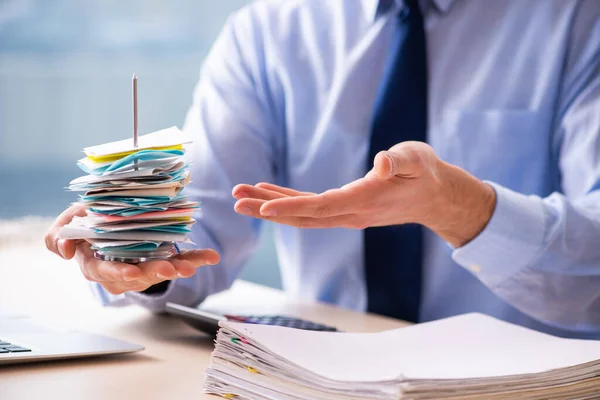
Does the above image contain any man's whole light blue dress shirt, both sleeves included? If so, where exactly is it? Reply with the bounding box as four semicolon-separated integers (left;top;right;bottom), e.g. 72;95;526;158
96;0;600;337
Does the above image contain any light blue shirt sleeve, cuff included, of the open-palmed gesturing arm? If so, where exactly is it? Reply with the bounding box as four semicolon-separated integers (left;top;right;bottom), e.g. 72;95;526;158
452;2;600;333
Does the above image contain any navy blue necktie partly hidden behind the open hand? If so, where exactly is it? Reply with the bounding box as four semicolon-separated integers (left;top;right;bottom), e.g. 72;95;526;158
364;0;427;322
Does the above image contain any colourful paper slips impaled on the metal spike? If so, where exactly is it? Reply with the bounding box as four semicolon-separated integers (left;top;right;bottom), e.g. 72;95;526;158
59;127;198;255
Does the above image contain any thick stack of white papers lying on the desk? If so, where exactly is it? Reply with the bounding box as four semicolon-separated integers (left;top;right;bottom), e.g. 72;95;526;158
205;314;600;400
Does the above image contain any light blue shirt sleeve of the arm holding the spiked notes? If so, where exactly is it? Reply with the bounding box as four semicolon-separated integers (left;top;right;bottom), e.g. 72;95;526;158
92;7;279;311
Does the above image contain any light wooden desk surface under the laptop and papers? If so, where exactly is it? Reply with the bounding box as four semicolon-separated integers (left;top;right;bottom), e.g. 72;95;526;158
0;243;405;400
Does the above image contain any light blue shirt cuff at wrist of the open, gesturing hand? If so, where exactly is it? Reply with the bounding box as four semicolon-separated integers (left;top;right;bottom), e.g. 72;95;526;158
452;182;545;288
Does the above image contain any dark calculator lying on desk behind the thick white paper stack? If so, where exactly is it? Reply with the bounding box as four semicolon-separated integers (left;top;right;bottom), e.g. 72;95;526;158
166;303;338;336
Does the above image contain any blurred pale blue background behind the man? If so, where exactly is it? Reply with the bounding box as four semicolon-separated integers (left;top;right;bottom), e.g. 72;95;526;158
0;0;280;287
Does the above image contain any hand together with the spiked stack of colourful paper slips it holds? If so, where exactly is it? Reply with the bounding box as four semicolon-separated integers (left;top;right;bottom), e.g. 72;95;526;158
45;75;219;294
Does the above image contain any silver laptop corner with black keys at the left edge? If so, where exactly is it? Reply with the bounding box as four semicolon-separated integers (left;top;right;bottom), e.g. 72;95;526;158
0;313;144;365
